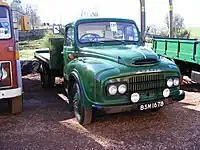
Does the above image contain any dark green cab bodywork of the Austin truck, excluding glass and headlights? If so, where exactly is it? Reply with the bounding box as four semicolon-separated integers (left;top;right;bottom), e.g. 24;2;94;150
34;18;184;111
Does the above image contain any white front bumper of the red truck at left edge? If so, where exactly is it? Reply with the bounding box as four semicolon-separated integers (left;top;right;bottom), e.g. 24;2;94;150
0;88;22;99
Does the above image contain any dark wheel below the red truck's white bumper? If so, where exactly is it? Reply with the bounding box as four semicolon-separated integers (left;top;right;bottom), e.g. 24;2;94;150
9;96;23;114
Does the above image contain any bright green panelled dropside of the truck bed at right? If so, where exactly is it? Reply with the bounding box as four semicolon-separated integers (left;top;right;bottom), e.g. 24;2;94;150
153;38;200;64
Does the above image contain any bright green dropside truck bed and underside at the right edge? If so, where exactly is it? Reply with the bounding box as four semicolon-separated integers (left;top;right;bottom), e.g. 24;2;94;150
152;37;200;83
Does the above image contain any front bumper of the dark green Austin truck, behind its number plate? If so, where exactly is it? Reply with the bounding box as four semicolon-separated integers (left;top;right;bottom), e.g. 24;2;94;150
92;90;185;113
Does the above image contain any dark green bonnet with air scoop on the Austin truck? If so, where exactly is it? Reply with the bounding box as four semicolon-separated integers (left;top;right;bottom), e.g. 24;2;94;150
82;45;159;66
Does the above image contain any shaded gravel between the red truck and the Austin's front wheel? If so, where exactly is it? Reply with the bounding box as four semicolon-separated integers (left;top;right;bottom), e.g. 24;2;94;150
0;75;104;150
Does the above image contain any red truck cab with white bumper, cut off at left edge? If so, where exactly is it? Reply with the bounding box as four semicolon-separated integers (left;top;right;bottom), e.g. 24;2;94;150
0;0;29;113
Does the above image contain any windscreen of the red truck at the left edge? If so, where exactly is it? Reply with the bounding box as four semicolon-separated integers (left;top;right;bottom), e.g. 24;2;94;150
0;6;11;40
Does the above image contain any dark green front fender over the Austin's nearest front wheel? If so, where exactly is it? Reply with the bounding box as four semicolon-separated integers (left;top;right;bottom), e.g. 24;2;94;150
64;59;114;107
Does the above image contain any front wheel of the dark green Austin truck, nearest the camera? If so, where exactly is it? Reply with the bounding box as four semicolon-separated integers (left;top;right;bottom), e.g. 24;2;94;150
69;82;92;125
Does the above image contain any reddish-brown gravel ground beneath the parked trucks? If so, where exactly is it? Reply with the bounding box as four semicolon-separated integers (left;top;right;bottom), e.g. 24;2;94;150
0;74;200;150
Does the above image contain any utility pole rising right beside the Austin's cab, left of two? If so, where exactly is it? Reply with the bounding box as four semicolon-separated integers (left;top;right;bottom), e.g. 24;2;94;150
140;0;146;45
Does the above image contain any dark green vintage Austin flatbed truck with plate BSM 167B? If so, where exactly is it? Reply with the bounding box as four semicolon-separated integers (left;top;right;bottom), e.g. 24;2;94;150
35;18;185;124
